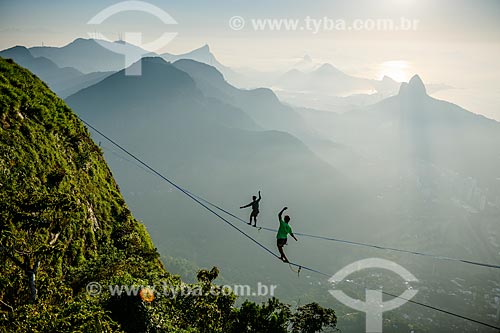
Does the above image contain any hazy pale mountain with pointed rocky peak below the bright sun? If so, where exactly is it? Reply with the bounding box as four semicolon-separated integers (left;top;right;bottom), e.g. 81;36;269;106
300;75;500;188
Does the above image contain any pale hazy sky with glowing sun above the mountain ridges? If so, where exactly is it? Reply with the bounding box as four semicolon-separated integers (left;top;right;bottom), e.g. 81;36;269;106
0;0;500;119
